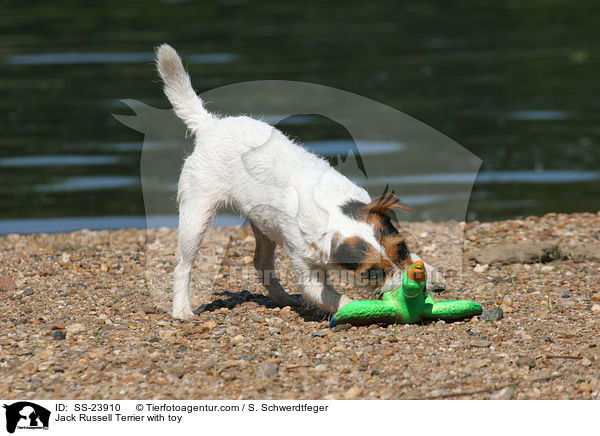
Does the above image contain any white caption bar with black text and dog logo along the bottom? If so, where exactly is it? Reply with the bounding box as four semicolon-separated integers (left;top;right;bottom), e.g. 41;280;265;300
0;400;597;436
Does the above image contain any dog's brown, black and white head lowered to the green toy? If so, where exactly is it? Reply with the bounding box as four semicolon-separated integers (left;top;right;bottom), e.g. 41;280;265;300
329;193;412;290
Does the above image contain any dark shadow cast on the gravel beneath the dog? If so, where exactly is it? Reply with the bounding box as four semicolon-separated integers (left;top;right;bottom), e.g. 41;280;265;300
194;290;329;322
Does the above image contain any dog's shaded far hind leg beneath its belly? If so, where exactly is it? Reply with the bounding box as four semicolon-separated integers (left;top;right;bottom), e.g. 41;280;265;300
250;221;298;307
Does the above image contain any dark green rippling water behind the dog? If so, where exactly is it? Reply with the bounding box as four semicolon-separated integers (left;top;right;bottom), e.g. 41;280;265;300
0;0;600;233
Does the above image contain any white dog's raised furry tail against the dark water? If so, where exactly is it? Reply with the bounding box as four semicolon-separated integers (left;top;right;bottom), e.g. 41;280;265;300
156;44;214;133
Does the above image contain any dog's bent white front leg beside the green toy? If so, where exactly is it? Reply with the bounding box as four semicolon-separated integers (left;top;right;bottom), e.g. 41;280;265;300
292;259;352;313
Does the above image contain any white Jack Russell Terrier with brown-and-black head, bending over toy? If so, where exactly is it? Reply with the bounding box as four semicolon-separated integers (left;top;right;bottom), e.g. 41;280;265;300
157;44;440;319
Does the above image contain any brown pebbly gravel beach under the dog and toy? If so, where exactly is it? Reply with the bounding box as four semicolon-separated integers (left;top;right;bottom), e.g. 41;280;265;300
0;213;600;399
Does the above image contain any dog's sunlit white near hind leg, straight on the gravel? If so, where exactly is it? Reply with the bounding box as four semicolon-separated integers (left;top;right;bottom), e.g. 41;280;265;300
173;197;217;319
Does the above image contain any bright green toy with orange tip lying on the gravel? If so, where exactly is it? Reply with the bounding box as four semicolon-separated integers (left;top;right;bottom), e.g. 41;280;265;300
329;261;482;327
